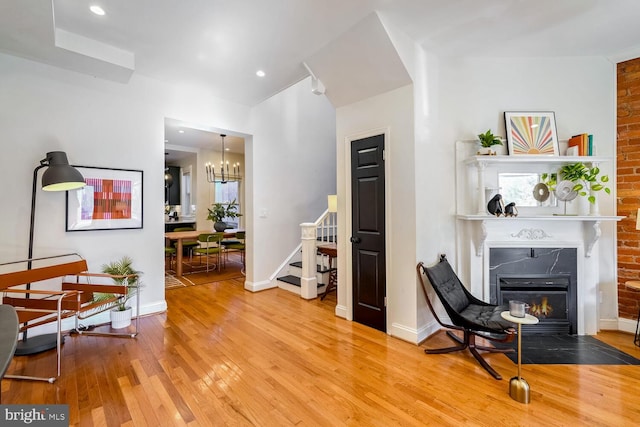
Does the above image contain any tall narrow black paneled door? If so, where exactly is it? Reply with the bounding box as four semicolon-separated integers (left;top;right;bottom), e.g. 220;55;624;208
351;135;387;332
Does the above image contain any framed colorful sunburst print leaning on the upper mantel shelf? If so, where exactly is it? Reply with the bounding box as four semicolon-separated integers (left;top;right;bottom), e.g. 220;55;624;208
504;111;560;156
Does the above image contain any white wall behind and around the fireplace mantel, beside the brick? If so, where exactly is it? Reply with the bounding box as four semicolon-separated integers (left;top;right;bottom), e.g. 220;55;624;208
416;57;617;332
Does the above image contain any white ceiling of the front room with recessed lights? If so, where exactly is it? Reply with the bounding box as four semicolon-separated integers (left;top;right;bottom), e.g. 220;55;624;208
0;0;640;157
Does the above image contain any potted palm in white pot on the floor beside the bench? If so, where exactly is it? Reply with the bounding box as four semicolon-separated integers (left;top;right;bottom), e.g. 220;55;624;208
94;256;142;329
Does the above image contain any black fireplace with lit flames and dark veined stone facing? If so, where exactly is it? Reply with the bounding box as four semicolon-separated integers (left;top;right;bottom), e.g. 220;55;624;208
489;248;578;334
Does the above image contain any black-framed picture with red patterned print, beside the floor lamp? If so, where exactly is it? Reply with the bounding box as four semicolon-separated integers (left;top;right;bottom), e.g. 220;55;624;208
66;166;142;231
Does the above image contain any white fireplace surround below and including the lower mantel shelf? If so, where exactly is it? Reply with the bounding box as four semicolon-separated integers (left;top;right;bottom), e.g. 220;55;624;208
459;219;618;335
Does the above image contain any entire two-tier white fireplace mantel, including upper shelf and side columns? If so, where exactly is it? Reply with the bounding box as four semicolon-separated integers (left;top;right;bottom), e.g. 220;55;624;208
454;140;624;335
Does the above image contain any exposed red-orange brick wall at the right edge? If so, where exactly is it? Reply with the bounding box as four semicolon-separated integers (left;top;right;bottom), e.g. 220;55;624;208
617;58;640;319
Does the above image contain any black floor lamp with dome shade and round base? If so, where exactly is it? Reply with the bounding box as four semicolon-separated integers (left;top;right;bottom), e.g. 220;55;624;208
15;151;86;356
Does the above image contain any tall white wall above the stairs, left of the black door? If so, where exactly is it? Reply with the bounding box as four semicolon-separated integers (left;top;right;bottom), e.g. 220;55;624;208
244;78;336;290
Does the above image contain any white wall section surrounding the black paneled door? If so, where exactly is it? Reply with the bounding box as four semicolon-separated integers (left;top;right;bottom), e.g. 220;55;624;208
336;85;417;342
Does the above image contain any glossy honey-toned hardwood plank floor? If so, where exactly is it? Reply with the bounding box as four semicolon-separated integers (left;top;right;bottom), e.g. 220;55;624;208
2;279;640;426
